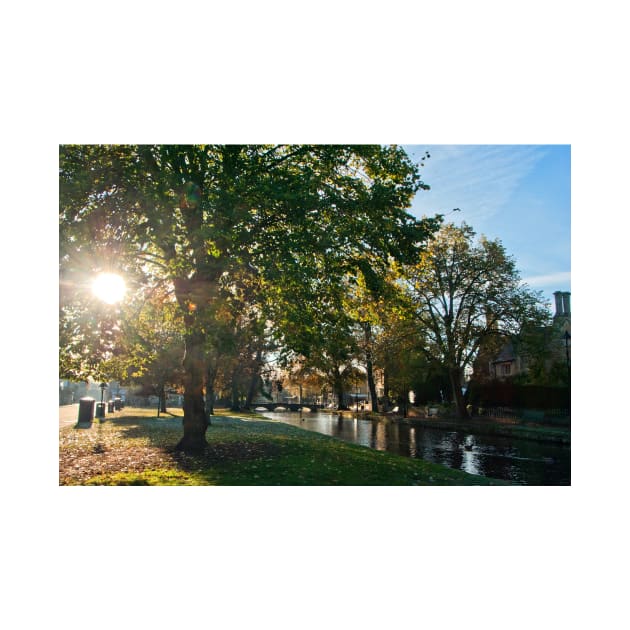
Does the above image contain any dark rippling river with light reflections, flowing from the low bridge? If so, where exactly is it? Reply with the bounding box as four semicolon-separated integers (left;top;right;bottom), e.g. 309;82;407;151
264;412;571;485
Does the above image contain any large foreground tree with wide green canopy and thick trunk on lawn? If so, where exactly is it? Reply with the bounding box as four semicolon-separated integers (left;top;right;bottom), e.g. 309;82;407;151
60;145;442;451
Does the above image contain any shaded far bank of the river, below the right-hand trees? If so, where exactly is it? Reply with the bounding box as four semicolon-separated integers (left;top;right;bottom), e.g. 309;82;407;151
331;411;571;446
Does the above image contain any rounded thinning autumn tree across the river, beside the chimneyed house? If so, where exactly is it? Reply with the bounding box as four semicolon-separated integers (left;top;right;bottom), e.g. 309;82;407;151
406;223;548;418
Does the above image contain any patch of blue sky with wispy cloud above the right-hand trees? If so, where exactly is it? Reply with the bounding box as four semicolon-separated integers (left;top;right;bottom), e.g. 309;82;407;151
404;145;571;312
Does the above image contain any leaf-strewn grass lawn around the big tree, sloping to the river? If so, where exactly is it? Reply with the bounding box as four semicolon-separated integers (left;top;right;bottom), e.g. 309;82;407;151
59;408;508;486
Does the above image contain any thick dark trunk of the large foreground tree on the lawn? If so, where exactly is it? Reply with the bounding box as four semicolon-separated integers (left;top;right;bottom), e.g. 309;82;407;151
175;332;209;453
